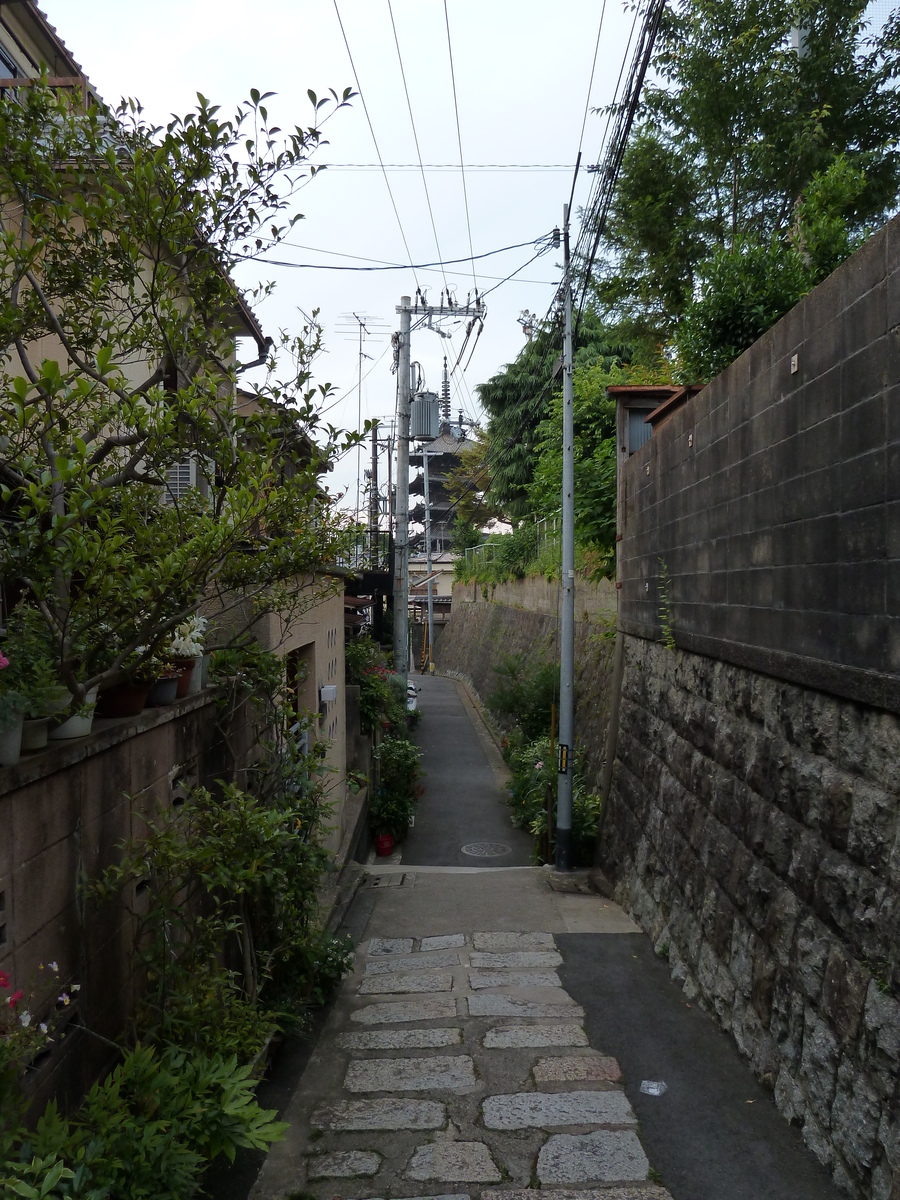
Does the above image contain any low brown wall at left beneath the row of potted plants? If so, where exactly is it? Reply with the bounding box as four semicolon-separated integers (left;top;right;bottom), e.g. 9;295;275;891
0;690;253;1103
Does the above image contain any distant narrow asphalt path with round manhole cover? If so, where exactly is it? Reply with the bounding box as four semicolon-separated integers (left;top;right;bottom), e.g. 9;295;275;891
402;674;532;866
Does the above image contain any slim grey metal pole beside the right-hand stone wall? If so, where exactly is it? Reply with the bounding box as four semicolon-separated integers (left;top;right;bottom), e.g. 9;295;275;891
556;204;575;871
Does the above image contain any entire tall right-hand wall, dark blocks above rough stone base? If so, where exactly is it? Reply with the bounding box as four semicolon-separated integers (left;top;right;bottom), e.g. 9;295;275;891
599;211;900;1200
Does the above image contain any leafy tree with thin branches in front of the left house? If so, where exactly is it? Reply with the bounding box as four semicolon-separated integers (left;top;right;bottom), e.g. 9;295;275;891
0;86;360;701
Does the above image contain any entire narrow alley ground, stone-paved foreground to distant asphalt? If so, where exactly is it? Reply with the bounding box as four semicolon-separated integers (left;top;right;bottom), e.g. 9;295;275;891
244;677;840;1200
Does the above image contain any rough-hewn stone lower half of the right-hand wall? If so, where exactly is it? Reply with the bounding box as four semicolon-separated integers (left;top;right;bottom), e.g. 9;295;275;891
601;637;900;1200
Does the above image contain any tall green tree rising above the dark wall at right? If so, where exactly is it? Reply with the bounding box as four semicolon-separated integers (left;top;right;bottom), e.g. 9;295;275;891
596;0;900;344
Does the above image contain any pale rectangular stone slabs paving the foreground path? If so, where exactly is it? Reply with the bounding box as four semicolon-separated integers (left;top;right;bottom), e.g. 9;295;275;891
252;931;671;1200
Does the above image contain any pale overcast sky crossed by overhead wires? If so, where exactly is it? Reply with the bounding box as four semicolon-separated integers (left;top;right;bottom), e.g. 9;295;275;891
40;0;634;509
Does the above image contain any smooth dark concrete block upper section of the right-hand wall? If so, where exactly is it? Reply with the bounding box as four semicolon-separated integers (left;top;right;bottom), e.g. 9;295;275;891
618;217;900;712
